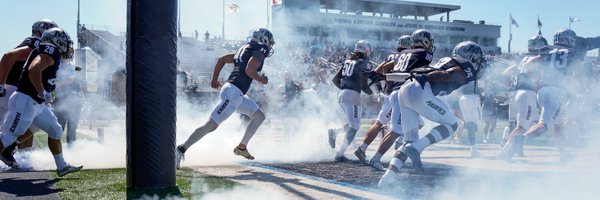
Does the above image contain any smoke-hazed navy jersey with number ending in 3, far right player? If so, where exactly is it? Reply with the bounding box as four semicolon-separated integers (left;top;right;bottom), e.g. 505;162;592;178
540;45;583;86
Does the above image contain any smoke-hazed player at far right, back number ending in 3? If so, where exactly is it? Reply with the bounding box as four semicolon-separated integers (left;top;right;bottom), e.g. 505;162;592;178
501;29;584;161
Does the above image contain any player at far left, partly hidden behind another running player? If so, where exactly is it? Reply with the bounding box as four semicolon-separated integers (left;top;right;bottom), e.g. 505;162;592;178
0;19;58;168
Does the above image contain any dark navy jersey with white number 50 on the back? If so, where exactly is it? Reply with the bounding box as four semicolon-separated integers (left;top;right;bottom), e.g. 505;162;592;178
340;59;369;93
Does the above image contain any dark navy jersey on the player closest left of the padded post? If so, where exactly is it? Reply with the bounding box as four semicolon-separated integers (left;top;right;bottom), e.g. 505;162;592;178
17;43;61;103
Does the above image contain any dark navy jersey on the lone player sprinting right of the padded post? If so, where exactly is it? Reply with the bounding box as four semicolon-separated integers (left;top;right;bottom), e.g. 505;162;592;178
227;42;269;94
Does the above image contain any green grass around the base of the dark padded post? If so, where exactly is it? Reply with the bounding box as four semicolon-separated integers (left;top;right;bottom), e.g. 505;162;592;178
52;169;237;199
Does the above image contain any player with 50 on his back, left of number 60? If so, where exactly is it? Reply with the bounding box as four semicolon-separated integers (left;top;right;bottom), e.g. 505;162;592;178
329;40;373;161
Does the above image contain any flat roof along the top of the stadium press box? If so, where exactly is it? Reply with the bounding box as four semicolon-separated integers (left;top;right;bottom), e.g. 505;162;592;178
320;0;460;16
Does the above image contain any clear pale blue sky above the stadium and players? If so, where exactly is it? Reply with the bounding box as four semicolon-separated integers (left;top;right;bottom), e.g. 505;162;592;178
0;0;600;52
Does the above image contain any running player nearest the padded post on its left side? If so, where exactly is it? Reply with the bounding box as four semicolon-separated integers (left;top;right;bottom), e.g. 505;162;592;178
0;28;83;177
